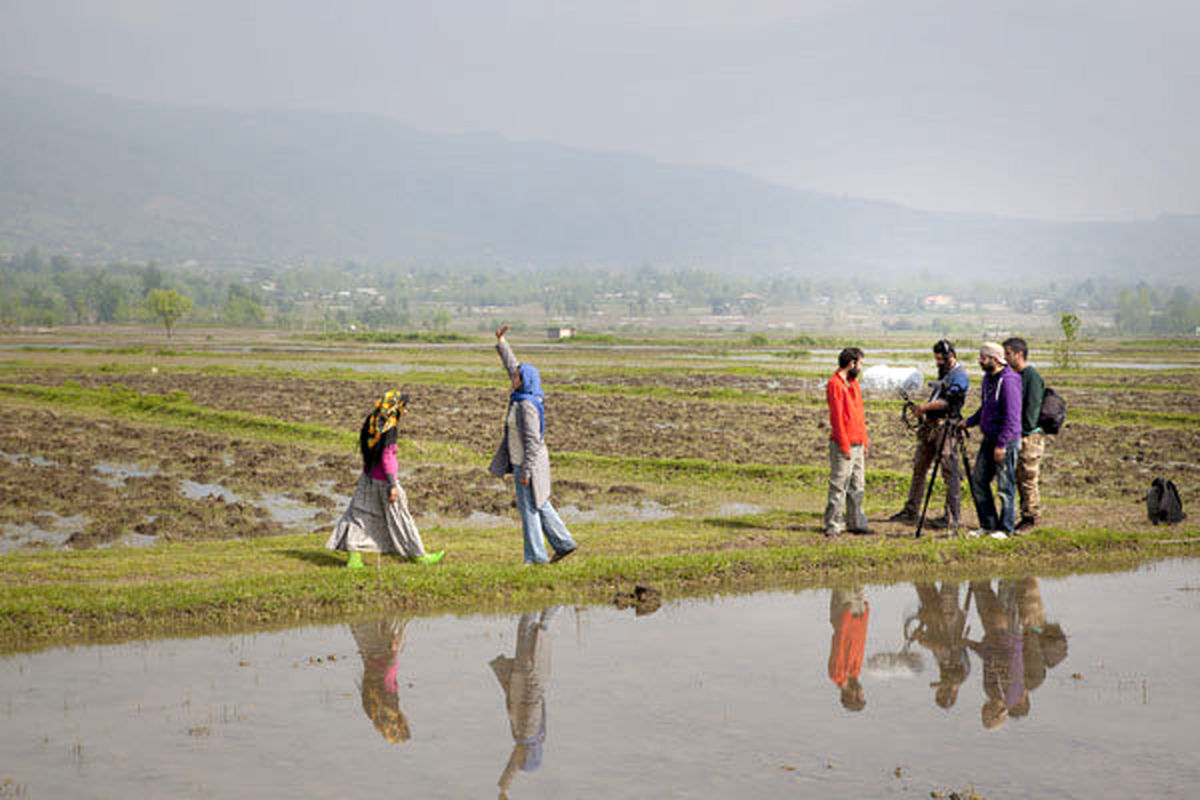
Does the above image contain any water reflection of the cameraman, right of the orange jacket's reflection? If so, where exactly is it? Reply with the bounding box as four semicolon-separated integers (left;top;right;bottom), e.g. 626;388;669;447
906;582;971;709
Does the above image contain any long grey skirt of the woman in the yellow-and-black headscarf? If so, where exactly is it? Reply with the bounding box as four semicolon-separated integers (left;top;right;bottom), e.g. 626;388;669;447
325;473;425;558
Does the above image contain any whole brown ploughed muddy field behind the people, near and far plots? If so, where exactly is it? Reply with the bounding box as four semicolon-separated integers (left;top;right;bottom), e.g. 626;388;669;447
0;340;1200;546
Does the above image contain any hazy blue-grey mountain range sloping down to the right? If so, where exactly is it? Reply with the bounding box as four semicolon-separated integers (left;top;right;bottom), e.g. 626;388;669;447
0;78;1200;277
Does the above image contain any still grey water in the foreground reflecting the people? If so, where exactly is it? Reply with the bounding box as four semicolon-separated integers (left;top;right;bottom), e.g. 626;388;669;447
0;560;1200;800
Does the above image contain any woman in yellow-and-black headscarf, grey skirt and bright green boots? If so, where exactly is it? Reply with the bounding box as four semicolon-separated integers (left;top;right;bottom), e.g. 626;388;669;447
325;390;445;569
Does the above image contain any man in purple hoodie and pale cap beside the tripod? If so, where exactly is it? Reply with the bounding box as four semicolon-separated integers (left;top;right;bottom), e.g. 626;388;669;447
961;342;1021;535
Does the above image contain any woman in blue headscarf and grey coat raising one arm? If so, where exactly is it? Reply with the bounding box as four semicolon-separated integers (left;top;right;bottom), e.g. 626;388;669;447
490;325;576;564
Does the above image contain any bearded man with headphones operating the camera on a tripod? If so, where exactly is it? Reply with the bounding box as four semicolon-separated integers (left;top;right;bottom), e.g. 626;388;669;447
888;339;971;529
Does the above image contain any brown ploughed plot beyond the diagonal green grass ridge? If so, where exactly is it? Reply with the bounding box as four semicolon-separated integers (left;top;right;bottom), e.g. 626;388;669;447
8;362;1200;497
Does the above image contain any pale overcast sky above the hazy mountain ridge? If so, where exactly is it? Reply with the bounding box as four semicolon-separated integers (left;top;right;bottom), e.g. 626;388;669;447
0;0;1200;219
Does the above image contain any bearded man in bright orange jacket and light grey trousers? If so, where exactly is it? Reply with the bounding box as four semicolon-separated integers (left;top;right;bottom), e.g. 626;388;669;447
824;348;875;536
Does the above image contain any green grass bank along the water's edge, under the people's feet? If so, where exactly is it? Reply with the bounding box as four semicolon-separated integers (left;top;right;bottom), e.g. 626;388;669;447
0;525;1200;652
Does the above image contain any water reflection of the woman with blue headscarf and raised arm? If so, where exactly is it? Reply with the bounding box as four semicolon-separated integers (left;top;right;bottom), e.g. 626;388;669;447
488;606;559;798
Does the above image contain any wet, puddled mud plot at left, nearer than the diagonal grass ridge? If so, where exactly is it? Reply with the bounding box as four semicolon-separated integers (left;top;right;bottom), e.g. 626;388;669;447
0;408;641;547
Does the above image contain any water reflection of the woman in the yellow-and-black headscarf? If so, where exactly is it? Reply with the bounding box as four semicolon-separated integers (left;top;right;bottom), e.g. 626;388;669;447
350;618;409;745
